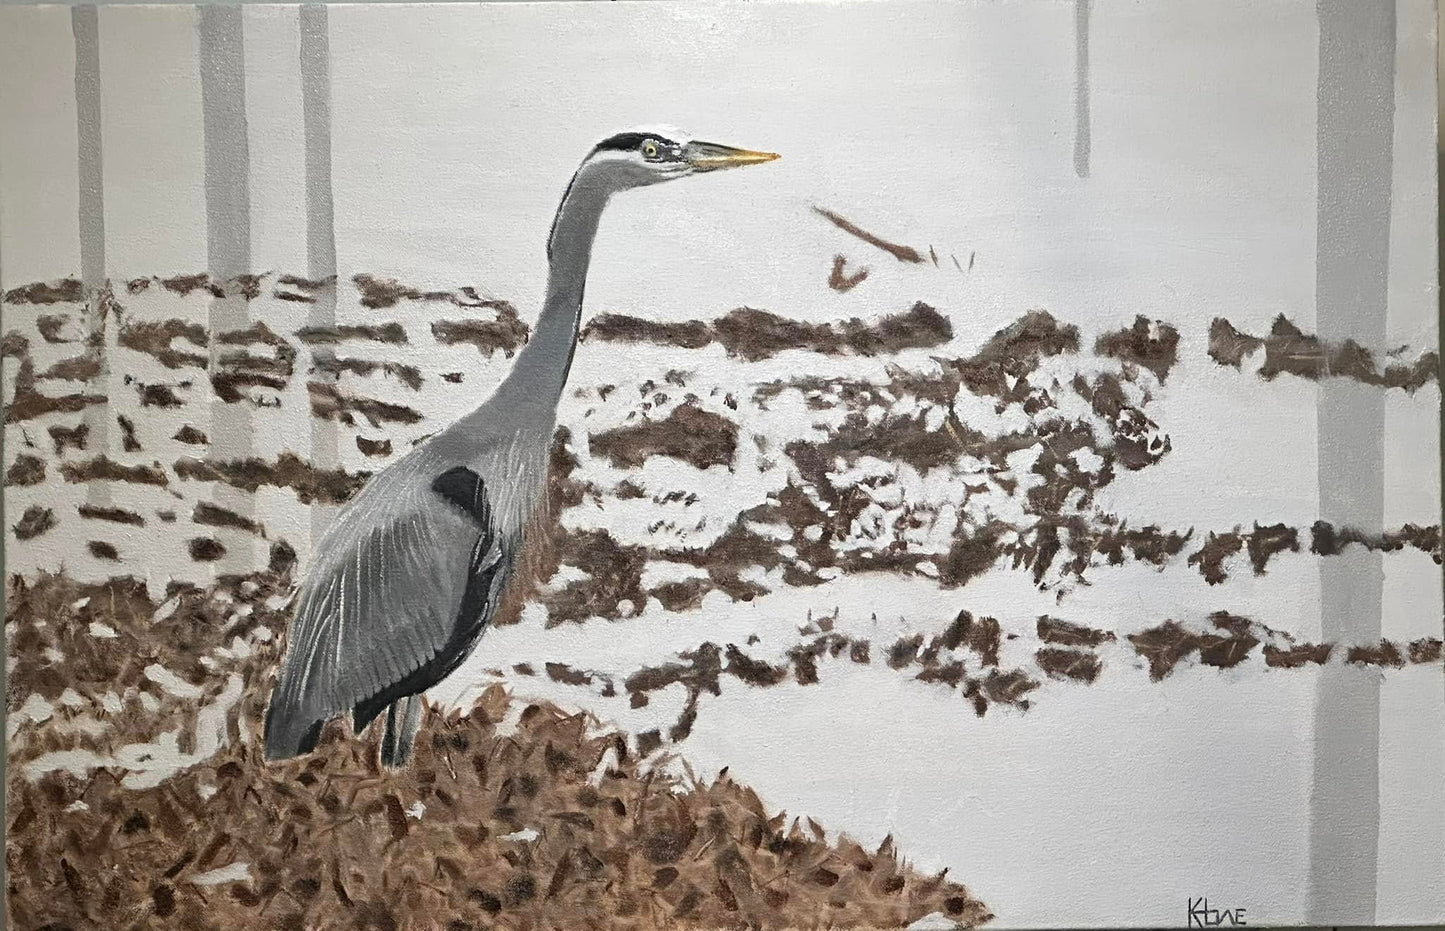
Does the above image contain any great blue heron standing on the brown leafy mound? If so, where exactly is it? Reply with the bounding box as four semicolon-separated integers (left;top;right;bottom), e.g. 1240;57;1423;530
266;130;777;766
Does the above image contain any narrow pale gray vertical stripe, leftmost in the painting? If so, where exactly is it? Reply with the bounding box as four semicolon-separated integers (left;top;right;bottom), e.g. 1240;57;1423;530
71;4;111;506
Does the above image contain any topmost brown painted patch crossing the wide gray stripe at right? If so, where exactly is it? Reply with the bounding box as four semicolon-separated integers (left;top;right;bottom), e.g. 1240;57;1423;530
1209;314;1439;393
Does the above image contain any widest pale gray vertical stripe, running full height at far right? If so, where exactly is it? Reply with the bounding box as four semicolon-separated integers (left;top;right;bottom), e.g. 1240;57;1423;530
1308;0;1394;925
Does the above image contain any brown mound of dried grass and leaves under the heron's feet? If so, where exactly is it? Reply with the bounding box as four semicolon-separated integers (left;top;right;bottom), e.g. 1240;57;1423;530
6;574;991;931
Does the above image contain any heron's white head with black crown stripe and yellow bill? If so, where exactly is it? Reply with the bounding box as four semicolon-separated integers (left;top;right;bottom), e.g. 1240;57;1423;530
584;129;777;191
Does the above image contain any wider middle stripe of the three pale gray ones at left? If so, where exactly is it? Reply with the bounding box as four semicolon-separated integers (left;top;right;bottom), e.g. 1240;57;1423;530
198;6;256;571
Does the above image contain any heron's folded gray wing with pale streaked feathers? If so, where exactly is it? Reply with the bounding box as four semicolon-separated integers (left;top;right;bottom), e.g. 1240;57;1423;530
267;468;501;743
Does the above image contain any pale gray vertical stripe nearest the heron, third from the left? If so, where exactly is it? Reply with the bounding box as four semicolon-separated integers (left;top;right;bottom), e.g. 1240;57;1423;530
301;3;340;544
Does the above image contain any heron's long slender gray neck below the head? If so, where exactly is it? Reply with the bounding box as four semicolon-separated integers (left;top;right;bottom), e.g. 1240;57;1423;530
497;168;611;409
